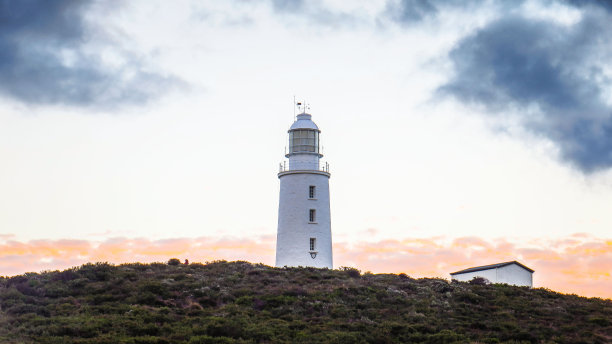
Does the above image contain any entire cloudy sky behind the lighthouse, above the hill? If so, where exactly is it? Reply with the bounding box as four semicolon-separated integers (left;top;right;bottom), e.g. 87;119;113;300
0;0;612;298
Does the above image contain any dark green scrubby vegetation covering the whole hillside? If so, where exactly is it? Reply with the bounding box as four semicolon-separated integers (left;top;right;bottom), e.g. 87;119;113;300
0;260;612;343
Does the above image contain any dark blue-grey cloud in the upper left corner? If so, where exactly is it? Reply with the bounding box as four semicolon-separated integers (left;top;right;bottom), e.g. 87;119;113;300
0;0;180;108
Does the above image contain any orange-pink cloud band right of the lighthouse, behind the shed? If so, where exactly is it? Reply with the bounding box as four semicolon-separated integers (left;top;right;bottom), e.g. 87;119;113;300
334;235;612;298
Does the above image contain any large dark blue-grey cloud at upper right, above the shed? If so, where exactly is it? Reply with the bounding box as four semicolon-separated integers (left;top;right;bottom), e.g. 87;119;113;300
440;11;612;173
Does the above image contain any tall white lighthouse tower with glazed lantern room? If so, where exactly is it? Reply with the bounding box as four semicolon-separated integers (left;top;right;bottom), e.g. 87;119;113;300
276;111;333;269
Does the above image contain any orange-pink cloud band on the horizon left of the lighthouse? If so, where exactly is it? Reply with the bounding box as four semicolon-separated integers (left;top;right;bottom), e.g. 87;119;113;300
0;236;274;275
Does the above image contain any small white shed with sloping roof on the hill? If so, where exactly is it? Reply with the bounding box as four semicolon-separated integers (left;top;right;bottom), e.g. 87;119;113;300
451;261;534;288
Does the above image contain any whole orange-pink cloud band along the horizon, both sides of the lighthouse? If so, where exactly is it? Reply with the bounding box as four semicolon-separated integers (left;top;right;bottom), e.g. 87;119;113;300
0;233;612;298
